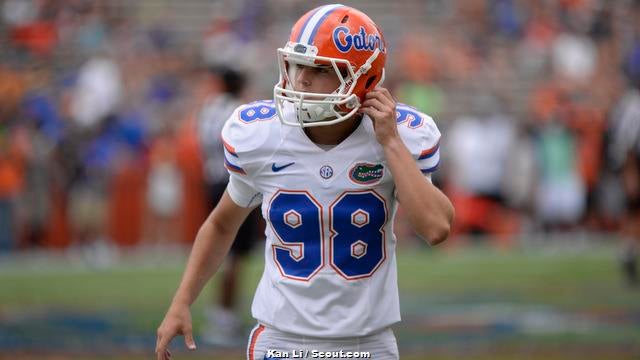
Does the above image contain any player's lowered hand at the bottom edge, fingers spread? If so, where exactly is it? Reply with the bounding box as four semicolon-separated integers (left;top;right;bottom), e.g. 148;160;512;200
156;304;196;360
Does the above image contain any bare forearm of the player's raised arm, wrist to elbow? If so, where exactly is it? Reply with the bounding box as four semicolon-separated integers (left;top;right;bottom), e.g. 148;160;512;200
384;138;454;245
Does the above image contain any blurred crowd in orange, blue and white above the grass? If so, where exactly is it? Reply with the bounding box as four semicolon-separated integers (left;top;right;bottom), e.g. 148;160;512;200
0;0;640;251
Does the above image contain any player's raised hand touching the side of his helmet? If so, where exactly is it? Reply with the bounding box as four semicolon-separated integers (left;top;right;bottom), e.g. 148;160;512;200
359;86;400;146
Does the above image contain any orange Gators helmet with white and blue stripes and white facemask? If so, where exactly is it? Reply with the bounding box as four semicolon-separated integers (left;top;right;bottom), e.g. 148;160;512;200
274;4;387;127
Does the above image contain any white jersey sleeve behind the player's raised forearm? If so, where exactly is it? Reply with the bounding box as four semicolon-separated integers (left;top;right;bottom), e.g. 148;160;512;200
397;105;440;179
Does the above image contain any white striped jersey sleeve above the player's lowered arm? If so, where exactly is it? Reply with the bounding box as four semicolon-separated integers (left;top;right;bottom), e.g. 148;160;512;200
221;103;276;207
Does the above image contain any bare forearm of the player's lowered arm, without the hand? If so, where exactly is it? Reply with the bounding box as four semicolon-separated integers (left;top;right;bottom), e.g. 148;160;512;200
173;214;236;306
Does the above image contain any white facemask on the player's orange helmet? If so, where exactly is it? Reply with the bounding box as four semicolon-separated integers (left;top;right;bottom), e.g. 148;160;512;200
274;41;379;127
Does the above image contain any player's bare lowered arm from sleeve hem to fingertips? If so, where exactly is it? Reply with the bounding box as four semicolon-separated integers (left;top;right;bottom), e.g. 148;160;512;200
156;191;253;360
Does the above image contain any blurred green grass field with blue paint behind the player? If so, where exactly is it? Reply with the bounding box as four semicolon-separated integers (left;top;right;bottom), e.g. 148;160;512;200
0;240;640;360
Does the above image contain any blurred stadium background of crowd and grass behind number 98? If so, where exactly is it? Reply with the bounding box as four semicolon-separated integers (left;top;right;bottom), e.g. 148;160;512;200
0;0;640;359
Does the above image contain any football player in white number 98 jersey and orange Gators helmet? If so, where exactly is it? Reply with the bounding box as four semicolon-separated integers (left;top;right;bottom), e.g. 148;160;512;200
156;4;454;360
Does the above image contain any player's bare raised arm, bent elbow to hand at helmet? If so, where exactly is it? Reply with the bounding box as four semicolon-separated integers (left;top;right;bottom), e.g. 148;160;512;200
361;87;454;245
